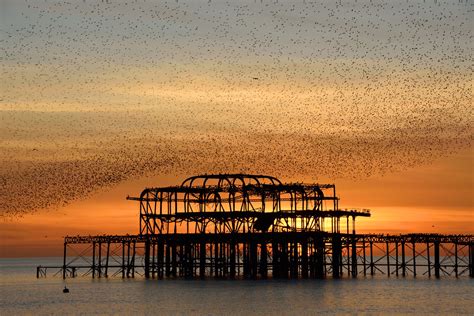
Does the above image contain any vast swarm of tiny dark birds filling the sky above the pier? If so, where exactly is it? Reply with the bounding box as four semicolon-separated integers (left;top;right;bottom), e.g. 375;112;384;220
0;0;473;215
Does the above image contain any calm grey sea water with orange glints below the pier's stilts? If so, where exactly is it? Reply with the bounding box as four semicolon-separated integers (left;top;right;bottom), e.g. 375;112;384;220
0;258;474;315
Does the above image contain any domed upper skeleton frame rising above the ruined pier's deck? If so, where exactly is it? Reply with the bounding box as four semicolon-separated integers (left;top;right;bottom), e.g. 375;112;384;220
128;174;370;235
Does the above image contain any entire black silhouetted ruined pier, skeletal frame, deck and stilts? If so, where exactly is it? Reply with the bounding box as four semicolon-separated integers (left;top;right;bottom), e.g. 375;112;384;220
37;174;474;279
